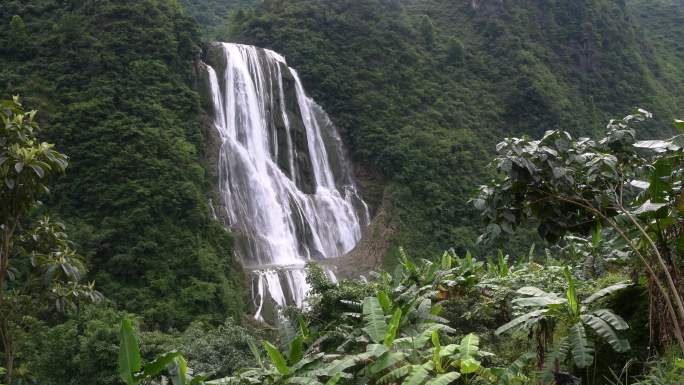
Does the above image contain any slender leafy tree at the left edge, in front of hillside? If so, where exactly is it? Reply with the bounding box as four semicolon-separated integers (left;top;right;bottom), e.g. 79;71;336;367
0;96;102;384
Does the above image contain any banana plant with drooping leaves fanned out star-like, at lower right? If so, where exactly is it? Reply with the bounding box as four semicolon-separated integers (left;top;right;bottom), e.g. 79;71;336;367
496;268;630;371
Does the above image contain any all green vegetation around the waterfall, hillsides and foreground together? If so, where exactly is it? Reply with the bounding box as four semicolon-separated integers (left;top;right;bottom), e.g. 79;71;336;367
0;0;684;385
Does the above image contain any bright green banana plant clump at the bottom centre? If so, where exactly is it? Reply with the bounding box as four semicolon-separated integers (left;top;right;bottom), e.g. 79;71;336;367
320;296;491;385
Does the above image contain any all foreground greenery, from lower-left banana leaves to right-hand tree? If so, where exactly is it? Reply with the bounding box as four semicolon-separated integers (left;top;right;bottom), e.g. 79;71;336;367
119;110;684;385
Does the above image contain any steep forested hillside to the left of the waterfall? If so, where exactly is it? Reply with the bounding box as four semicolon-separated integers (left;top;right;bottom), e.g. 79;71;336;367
0;0;244;328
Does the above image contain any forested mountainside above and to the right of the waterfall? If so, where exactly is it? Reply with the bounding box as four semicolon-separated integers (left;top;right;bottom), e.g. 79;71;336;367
219;0;684;255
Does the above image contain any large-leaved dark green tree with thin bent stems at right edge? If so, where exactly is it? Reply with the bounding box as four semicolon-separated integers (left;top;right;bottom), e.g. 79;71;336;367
474;110;684;352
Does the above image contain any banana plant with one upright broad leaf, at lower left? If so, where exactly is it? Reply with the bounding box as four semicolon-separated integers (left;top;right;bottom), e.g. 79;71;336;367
118;318;204;385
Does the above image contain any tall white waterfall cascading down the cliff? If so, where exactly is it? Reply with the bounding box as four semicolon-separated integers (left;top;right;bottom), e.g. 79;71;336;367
207;43;369;318
